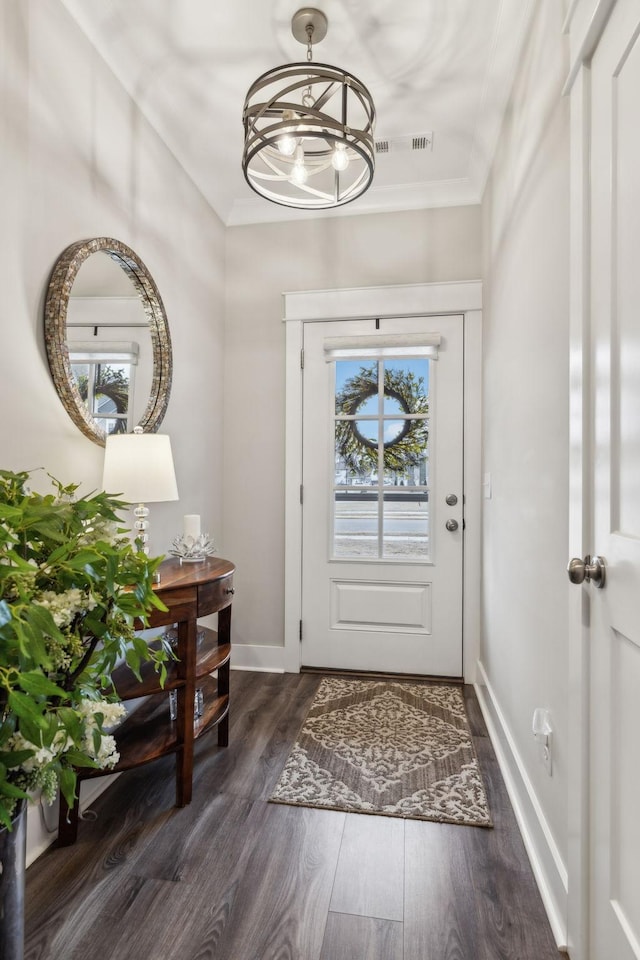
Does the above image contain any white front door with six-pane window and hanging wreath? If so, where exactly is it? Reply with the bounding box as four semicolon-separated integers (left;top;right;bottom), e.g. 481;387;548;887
301;316;463;677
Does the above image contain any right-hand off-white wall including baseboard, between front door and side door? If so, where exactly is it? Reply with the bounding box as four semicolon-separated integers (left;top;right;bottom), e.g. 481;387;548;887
481;0;569;939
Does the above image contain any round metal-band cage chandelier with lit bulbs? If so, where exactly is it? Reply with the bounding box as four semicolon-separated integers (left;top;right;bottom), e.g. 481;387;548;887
242;7;376;210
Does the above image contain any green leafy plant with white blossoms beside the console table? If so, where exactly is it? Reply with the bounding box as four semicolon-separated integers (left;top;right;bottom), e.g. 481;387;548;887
0;470;170;828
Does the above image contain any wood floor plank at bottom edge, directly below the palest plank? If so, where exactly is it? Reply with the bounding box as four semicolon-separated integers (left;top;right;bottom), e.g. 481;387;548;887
320;913;403;960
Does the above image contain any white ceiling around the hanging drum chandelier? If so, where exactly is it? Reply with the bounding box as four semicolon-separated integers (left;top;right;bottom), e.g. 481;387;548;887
62;0;535;225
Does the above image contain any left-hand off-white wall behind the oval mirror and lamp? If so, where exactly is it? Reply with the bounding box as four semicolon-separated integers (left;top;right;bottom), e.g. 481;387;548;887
0;0;224;856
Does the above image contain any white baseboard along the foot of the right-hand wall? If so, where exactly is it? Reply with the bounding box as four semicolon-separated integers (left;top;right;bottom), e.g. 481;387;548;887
474;662;568;951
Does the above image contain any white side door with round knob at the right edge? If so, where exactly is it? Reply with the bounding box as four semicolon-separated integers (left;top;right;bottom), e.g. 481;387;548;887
582;0;640;960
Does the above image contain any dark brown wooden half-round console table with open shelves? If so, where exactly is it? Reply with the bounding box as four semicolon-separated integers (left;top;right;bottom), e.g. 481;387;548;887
58;557;235;846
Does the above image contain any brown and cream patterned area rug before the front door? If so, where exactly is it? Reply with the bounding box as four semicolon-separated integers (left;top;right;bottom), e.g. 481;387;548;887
269;677;492;827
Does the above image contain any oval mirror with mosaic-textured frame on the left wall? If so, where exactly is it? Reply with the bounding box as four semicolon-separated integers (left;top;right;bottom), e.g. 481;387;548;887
44;237;172;445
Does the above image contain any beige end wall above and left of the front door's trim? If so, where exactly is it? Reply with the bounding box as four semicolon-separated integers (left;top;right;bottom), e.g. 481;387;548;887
222;207;481;662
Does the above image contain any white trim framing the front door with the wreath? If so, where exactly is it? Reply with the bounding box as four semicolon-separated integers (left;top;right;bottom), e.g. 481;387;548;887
282;280;482;683
